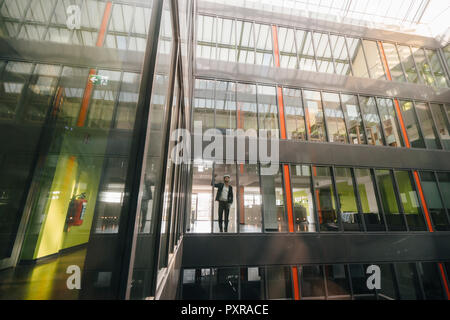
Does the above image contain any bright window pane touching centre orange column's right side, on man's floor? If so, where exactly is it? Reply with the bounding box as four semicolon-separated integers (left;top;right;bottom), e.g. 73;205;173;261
291;165;316;232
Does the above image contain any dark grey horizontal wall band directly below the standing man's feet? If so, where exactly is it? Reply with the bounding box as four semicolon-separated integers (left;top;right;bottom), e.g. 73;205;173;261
183;233;450;268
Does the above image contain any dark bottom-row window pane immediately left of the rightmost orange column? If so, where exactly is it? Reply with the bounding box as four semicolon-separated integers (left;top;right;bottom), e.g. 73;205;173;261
417;262;446;300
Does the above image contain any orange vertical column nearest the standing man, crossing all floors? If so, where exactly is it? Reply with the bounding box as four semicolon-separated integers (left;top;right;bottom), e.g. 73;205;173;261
272;26;300;300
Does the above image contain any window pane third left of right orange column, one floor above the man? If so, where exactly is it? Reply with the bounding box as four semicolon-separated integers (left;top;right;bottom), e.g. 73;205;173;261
341;94;366;144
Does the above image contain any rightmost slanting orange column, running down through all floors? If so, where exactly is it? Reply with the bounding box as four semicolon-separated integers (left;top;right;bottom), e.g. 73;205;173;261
378;41;450;300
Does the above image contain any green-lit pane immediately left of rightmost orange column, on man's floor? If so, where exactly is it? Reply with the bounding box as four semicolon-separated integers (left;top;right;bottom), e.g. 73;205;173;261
394;170;427;231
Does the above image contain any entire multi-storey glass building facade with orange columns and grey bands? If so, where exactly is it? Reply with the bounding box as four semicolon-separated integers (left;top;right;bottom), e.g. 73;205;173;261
0;0;450;300
